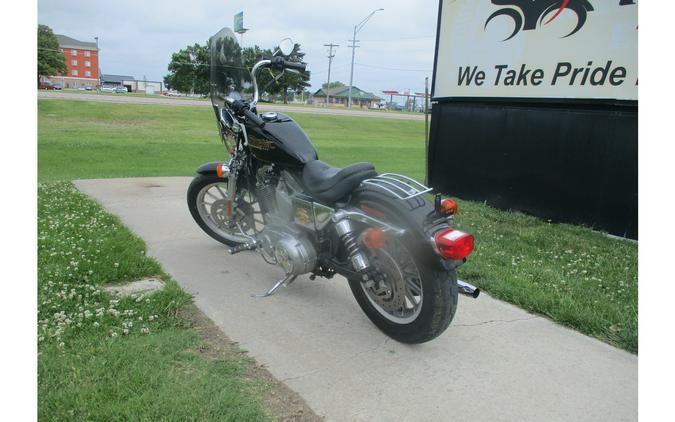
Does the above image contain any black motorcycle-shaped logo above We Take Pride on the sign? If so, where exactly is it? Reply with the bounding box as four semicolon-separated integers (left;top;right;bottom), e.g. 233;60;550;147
483;0;596;41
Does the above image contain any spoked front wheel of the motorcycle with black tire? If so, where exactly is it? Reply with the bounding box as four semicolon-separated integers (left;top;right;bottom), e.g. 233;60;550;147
187;175;265;246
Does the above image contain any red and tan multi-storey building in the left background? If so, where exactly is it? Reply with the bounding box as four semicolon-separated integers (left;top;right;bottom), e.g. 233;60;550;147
49;34;100;88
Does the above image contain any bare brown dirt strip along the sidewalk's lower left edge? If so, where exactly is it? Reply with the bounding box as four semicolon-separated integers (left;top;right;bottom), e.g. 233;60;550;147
179;305;324;422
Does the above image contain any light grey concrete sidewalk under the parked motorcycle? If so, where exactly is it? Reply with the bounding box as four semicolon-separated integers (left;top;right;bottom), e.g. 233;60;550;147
75;177;638;422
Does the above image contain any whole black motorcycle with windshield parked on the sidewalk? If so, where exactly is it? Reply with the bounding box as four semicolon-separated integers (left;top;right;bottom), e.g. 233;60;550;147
187;28;479;343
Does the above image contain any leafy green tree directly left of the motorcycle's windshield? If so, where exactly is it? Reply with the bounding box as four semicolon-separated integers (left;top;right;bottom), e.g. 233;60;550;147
164;43;209;94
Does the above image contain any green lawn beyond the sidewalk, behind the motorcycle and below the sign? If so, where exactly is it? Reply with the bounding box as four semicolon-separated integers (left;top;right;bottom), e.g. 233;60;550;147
38;100;638;352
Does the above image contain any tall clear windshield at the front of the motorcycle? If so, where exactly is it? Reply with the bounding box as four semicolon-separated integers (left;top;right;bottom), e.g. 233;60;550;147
209;28;252;108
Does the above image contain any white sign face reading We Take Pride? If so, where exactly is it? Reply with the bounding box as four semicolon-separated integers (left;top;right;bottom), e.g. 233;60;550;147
433;0;638;100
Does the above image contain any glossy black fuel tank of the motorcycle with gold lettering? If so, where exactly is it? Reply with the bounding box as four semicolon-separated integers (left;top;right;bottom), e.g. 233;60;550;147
246;112;319;167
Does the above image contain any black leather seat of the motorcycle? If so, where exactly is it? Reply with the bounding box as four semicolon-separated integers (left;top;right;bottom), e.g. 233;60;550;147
302;160;377;204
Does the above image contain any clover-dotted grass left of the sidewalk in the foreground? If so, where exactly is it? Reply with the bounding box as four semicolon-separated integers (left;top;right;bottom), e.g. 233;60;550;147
38;182;269;421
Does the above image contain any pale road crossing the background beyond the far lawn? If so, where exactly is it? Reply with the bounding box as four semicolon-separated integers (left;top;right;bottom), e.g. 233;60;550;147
38;91;424;120
